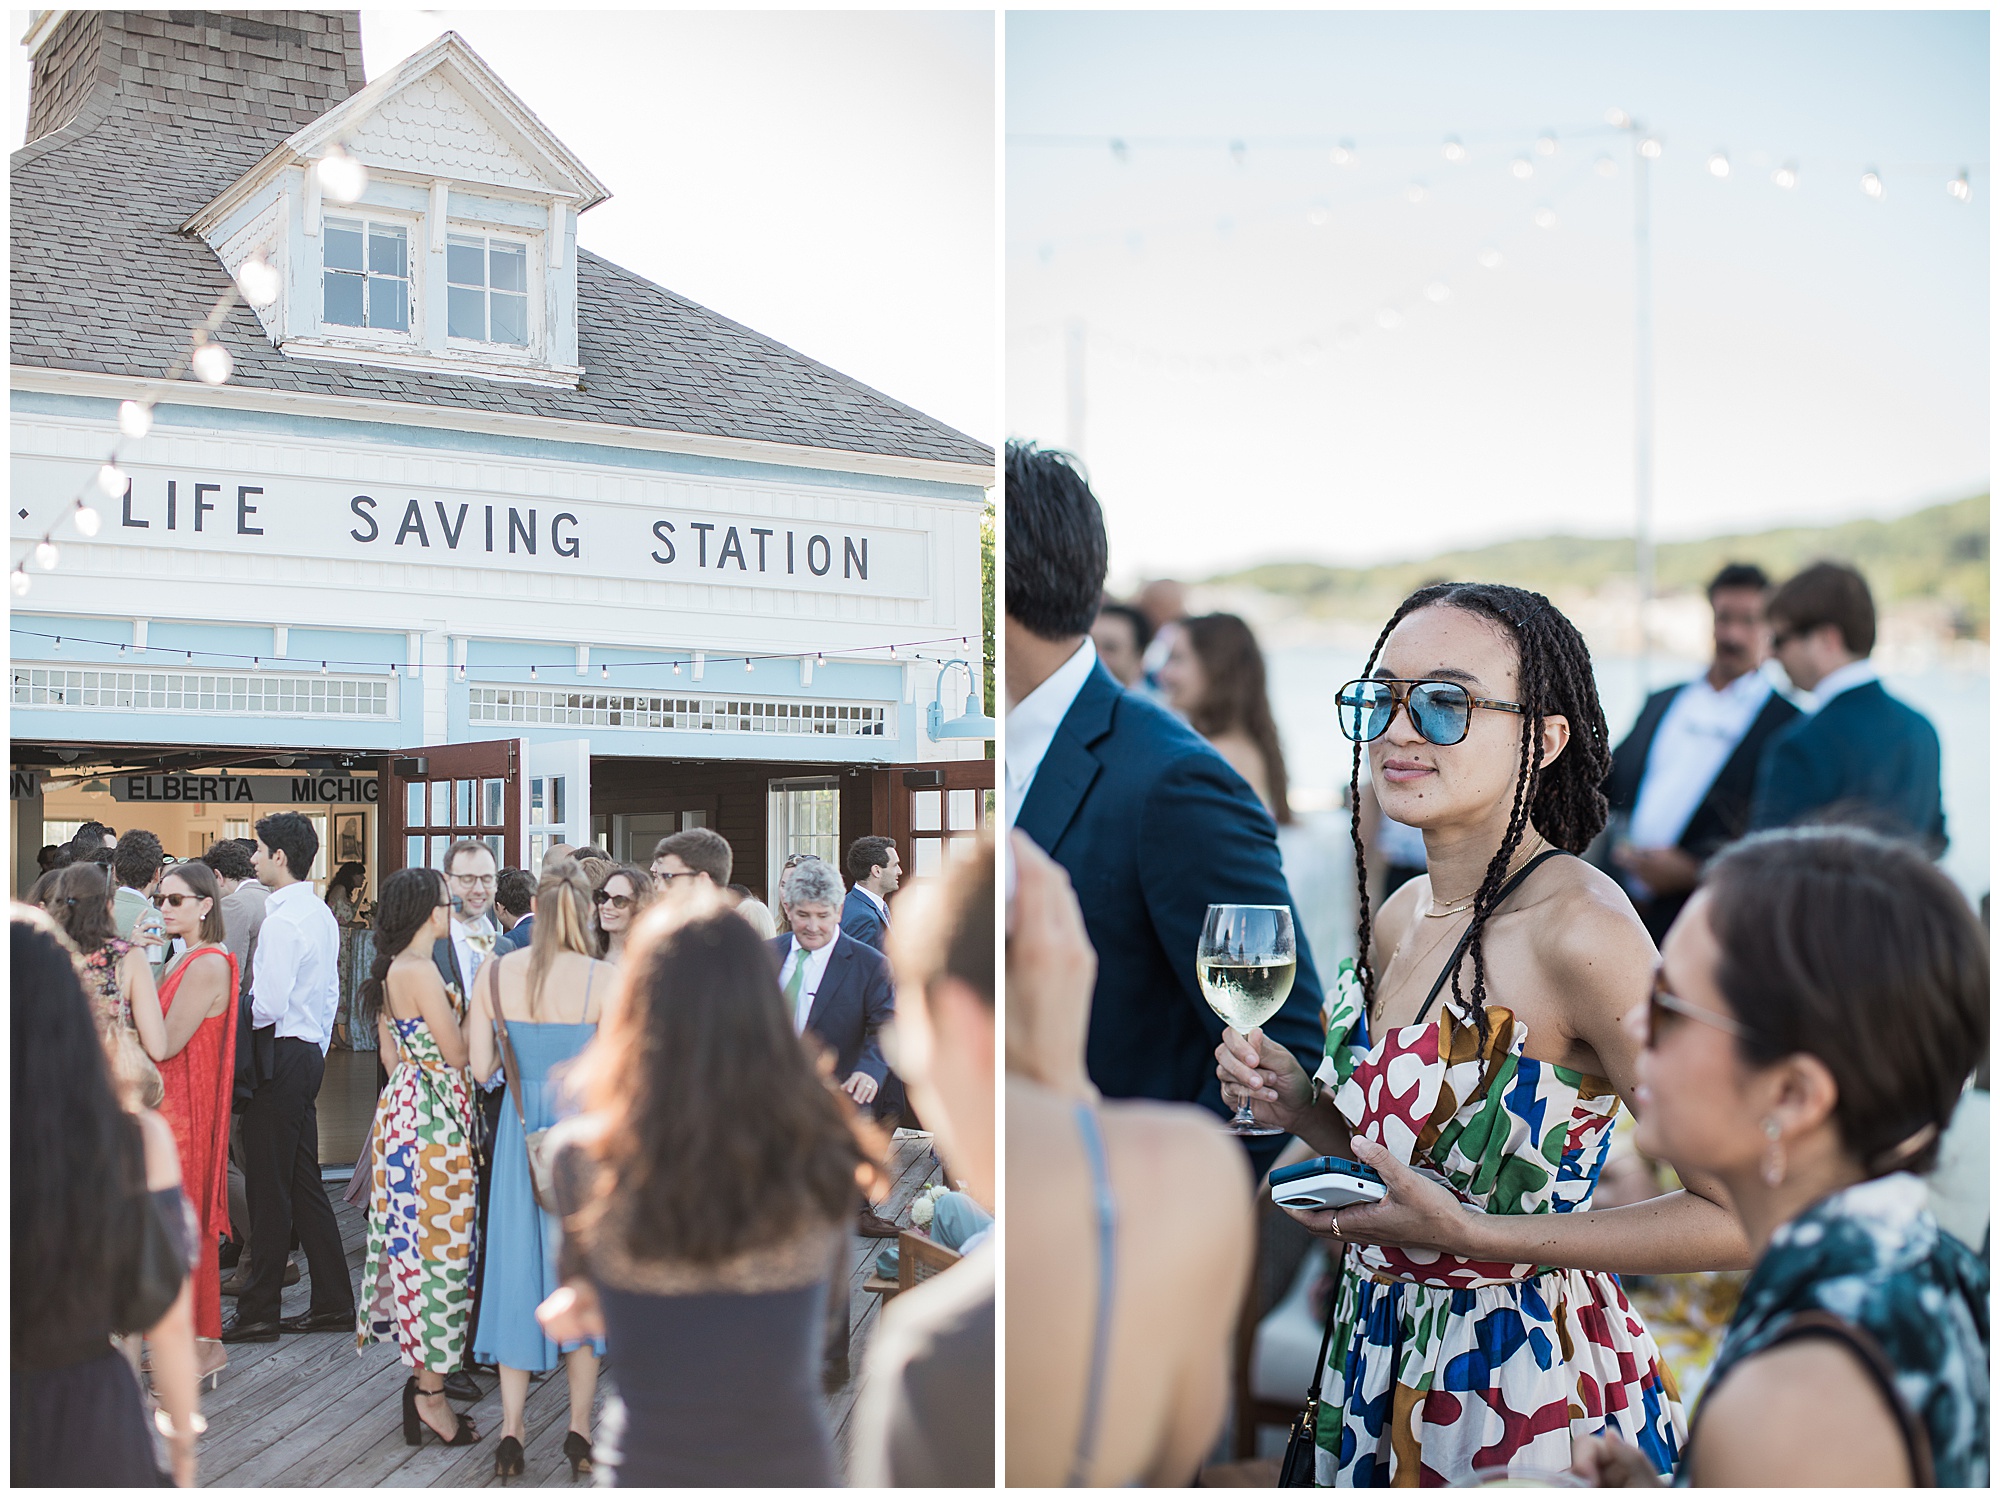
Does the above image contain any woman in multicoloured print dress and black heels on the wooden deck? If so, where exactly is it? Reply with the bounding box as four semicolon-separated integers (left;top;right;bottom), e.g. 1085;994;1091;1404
354;868;480;1446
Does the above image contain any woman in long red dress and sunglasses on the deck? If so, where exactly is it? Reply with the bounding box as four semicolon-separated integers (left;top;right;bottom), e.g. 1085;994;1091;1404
132;862;236;1378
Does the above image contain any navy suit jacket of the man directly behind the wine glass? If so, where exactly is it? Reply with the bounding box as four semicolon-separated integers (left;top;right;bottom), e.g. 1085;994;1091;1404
1014;664;1324;1170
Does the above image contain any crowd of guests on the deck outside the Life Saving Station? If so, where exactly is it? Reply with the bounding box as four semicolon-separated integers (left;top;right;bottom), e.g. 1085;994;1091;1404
14;812;994;1484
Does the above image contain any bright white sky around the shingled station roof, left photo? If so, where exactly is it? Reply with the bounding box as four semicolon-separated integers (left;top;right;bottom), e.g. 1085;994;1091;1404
10;10;998;442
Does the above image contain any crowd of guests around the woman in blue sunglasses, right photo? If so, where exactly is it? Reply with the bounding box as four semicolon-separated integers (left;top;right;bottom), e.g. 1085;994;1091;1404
1006;444;1988;1486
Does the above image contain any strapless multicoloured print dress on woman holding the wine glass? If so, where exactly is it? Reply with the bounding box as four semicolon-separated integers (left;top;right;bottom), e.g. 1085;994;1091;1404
1318;960;1686;1488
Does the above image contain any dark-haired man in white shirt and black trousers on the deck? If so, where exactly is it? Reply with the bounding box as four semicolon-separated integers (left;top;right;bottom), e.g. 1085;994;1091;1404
222;812;354;1342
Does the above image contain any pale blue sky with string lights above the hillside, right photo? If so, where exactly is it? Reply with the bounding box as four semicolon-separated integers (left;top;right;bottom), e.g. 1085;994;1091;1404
1006;12;1992;582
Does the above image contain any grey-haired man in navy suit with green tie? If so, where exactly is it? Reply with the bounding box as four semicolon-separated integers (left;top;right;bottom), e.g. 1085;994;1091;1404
770;858;896;1238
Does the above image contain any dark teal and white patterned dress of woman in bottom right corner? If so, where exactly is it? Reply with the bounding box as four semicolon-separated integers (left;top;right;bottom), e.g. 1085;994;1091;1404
1676;1172;1990;1488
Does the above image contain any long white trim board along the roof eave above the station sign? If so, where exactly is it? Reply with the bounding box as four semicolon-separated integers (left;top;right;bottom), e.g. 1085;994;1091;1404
8;364;996;488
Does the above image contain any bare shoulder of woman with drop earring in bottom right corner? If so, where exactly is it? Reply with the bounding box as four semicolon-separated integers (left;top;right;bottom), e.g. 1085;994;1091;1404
1694;1336;1914;1488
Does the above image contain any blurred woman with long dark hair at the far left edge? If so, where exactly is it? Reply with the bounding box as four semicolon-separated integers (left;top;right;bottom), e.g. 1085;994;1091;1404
8;906;204;1488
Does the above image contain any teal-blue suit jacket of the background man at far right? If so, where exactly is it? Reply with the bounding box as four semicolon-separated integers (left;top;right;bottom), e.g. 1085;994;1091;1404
1750;682;1944;858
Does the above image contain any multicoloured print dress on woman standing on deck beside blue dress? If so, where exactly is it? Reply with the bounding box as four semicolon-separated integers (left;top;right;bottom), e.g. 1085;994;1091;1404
354;996;478;1372
